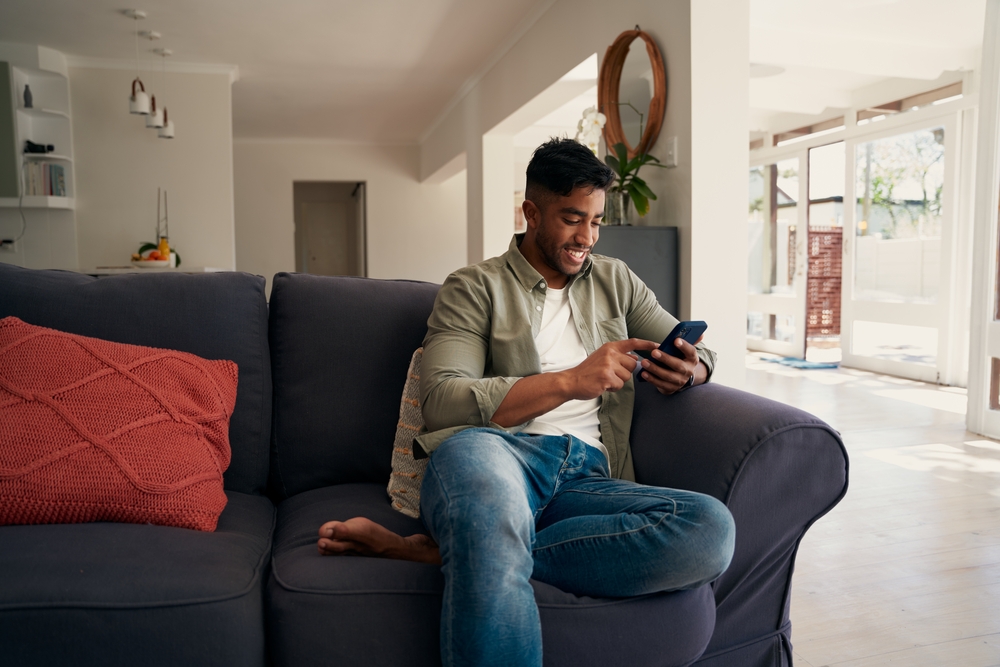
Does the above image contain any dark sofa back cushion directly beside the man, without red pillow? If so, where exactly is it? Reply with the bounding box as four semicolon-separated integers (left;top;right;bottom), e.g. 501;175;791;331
269;273;438;500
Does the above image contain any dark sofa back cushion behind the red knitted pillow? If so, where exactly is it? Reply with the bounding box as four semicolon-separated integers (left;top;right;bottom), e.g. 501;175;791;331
0;264;271;494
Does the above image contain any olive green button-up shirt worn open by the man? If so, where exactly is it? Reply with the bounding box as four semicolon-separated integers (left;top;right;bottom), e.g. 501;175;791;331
414;235;715;480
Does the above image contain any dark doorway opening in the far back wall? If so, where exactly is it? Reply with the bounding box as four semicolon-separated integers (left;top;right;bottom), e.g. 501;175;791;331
292;181;367;277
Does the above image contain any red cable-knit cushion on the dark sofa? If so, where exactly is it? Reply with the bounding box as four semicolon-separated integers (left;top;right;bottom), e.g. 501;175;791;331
0;317;237;530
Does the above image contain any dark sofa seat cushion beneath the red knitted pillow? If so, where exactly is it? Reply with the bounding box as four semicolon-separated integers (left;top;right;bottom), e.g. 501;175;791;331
0;492;274;666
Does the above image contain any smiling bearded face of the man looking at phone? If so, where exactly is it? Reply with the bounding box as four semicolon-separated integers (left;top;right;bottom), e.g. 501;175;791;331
521;188;605;289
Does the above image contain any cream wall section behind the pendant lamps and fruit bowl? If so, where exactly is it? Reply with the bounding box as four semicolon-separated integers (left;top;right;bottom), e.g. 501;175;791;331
69;67;236;269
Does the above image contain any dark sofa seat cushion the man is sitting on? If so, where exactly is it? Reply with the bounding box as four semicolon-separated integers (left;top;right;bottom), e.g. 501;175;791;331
267;483;715;667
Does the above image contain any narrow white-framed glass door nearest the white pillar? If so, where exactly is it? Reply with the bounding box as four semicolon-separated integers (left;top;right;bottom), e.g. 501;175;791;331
747;151;808;359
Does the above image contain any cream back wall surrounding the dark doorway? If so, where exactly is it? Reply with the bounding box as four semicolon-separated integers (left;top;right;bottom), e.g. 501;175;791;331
233;139;466;289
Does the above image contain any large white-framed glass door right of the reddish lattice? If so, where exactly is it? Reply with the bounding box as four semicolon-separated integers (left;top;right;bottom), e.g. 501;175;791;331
841;116;961;382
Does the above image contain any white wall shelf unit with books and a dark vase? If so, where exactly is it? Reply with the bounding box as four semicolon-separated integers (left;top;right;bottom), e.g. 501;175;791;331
0;42;77;269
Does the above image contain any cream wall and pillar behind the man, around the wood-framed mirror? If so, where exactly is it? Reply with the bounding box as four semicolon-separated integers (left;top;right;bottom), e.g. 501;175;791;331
420;0;749;387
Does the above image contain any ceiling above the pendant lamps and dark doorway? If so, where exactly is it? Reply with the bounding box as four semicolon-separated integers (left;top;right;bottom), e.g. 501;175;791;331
0;0;551;143
